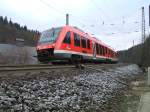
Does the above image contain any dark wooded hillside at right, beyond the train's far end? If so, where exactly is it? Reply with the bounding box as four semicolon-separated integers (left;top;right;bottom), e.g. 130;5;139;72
118;35;150;66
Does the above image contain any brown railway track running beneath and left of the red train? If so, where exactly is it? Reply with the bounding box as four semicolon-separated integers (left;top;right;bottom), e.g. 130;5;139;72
0;63;127;72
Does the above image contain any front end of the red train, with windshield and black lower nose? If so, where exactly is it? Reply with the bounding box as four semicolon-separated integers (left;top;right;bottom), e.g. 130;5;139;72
36;27;62;62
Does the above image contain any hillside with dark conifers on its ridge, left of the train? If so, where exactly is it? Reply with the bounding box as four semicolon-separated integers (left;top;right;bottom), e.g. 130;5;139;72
0;16;40;46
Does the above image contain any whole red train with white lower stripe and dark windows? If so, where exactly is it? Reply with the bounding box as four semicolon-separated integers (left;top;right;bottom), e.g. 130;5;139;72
36;26;118;63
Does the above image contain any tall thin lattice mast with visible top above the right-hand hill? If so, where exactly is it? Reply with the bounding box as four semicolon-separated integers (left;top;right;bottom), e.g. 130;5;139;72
142;7;145;44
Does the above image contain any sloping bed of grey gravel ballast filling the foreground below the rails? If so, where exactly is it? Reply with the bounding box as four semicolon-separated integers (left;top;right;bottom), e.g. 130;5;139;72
0;65;142;112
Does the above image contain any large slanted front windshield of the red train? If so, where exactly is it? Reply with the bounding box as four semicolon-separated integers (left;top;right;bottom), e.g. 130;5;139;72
38;27;61;44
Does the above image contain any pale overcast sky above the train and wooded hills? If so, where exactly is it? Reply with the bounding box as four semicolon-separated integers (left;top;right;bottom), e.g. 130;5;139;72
0;0;150;50
